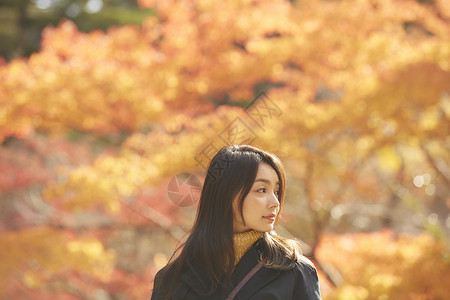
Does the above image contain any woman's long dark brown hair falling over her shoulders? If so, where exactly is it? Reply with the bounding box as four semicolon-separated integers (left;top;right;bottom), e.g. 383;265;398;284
158;145;301;299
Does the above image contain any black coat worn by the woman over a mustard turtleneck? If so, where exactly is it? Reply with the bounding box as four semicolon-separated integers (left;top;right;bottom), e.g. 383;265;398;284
151;239;321;300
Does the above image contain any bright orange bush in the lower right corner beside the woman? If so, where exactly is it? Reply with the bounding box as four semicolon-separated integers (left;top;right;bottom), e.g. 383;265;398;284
317;230;450;299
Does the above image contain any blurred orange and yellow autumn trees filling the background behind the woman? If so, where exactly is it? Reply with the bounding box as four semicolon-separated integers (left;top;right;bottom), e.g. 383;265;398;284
0;0;450;300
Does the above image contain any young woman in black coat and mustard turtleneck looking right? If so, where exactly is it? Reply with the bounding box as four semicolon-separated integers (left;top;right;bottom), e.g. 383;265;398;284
151;145;321;300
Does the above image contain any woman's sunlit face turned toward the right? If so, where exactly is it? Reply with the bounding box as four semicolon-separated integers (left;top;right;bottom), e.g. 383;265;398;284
233;163;280;233
